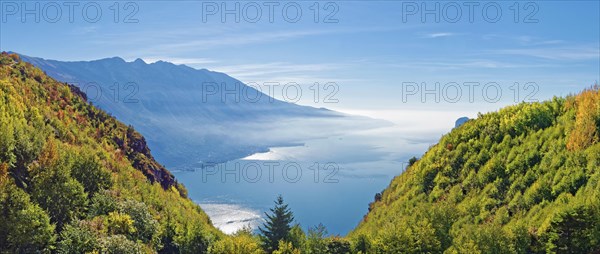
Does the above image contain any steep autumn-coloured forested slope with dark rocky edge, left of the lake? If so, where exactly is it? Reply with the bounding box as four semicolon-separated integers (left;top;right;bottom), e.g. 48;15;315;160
0;53;223;253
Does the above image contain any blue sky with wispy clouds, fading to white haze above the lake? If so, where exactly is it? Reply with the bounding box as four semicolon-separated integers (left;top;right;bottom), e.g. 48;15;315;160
0;0;600;123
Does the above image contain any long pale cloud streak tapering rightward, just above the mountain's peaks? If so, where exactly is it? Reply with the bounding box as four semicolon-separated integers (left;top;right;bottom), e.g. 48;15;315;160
87;26;408;56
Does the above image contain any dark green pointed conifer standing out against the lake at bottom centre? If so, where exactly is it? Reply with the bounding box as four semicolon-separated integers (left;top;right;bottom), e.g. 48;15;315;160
258;195;294;253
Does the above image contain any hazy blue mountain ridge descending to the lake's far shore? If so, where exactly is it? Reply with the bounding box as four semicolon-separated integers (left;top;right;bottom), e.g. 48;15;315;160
22;53;381;168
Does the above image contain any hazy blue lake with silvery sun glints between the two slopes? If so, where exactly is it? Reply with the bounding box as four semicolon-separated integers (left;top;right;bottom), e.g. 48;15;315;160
174;116;452;235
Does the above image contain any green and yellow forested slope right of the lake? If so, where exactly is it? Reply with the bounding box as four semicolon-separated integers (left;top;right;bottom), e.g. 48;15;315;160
349;86;600;253
